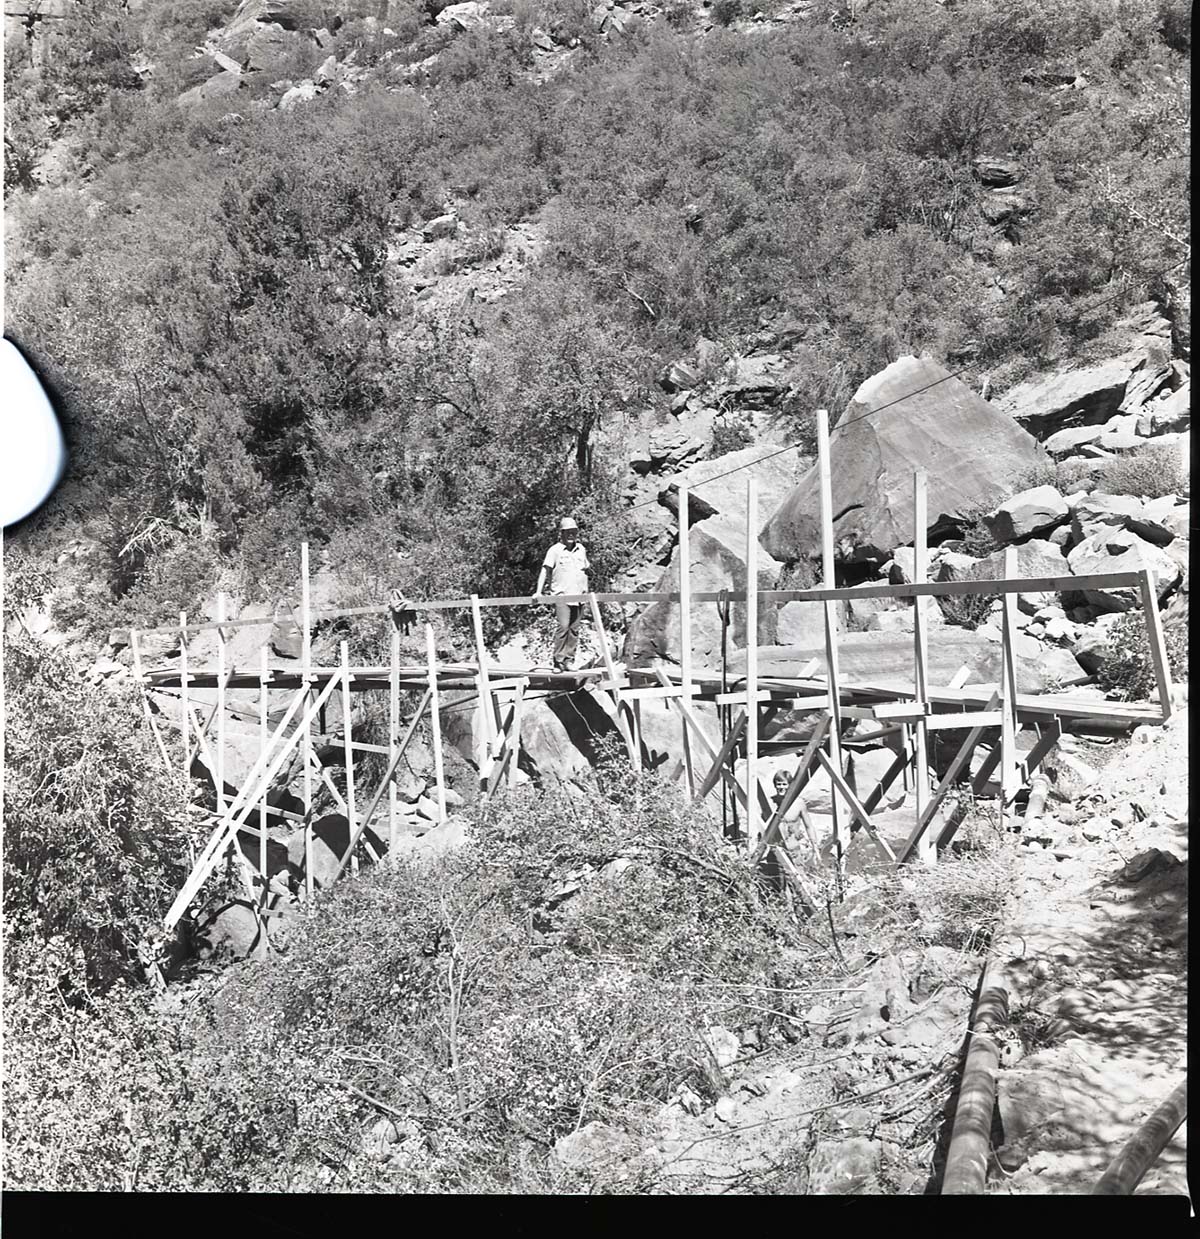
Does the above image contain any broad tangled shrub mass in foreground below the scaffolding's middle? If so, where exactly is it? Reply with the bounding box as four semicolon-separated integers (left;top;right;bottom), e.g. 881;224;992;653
117;779;807;1191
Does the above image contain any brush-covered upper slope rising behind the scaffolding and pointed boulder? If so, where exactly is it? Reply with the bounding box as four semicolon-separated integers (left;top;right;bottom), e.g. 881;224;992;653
6;0;1190;636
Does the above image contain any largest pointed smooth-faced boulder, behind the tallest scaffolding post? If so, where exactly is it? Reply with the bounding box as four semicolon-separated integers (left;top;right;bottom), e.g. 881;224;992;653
762;357;1046;563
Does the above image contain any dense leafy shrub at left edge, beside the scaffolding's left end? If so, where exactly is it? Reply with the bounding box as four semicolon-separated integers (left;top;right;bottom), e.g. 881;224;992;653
4;638;188;996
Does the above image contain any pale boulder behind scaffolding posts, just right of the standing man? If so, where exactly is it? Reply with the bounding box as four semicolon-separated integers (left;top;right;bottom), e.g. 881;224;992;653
623;513;783;668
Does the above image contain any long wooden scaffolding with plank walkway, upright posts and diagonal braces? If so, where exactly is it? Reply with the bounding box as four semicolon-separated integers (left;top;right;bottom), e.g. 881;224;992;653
130;411;1172;930
